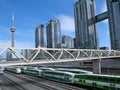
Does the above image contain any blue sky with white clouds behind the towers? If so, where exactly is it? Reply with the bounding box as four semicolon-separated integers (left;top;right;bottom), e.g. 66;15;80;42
0;0;110;47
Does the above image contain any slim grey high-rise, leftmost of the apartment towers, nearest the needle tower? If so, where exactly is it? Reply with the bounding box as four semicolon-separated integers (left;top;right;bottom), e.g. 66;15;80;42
35;24;44;48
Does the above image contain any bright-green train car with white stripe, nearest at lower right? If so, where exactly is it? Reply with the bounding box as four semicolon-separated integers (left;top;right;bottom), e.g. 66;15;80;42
74;74;120;90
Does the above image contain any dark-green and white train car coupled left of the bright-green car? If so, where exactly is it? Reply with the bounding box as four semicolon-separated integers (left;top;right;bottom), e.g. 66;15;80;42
40;70;75;83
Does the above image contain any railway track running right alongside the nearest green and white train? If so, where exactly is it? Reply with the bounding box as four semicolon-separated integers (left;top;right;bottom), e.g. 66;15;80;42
7;72;87;90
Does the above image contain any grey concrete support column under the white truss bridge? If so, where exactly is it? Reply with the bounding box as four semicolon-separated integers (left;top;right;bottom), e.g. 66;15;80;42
93;59;101;74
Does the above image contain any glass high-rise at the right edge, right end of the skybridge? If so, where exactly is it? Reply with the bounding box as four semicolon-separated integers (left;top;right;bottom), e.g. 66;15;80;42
107;0;120;50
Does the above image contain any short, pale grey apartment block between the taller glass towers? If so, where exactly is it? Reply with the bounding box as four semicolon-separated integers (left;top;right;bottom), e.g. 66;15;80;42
62;36;74;48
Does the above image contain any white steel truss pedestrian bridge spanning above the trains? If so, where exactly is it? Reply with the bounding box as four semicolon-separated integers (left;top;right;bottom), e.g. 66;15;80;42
0;47;120;67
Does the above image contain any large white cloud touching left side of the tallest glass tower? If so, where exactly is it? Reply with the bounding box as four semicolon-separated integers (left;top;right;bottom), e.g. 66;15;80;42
57;14;75;37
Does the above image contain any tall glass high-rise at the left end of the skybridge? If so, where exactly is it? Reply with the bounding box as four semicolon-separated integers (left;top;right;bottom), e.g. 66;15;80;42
74;0;98;49
